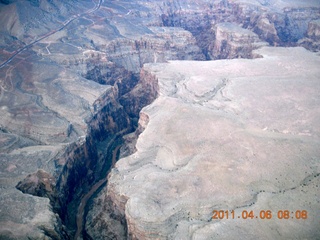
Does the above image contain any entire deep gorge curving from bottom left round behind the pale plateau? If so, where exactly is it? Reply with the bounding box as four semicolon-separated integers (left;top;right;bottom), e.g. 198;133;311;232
1;1;320;239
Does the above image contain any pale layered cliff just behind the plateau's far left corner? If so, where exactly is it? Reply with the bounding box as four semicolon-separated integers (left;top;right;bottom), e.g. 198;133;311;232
100;27;205;73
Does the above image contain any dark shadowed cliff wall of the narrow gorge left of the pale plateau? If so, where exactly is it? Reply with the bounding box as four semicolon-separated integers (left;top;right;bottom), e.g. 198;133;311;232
53;69;157;234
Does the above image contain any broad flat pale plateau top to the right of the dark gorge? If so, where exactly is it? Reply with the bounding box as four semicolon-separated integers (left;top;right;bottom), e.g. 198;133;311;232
108;47;320;239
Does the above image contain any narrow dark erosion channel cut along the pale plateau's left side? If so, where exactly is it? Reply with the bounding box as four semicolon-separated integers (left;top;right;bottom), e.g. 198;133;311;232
52;68;157;239
